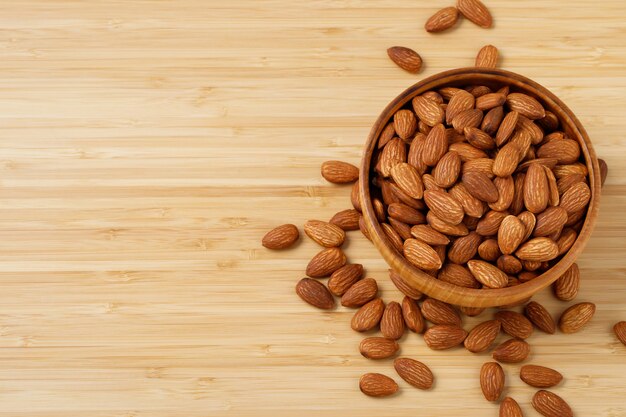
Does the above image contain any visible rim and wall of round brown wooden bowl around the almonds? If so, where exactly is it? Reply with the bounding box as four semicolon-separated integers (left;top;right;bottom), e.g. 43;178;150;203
359;67;600;307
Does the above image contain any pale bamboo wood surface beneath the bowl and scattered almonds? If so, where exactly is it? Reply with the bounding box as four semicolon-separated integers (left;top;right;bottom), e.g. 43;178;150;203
0;0;626;417
